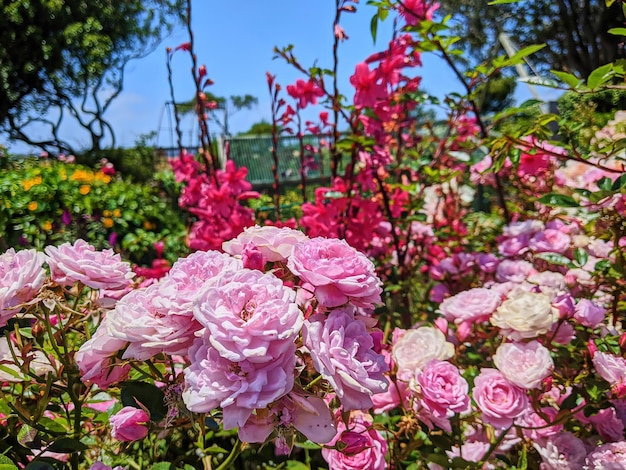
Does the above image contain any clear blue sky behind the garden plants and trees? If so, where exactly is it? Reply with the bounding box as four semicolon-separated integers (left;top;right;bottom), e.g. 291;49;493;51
0;0;556;153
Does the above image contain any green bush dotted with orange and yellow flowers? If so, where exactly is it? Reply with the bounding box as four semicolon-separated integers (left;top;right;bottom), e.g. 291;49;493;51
0;159;185;264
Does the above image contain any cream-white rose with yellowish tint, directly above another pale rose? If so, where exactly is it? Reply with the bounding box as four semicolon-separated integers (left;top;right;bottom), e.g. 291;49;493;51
491;290;559;340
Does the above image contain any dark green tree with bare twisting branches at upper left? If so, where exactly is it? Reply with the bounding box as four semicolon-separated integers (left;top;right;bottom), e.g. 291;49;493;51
0;0;184;152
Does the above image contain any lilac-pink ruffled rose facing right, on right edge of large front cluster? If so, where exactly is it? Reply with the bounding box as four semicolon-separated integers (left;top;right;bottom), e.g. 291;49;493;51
302;308;389;411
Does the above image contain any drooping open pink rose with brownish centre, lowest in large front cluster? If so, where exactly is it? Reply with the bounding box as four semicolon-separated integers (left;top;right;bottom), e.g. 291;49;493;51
239;392;337;444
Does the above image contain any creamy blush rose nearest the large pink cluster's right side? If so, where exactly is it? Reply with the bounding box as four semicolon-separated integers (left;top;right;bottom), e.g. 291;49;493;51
393;326;454;381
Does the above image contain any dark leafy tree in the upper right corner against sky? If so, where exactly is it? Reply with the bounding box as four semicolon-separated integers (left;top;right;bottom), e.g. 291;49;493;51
439;0;626;78
